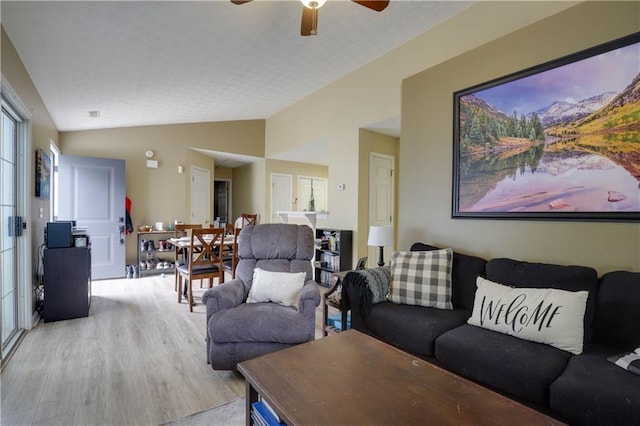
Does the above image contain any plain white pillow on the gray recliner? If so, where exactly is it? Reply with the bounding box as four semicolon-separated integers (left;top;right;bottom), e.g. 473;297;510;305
247;268;307;306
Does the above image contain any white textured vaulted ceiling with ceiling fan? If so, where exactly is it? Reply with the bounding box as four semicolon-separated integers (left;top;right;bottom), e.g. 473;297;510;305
0;0;473;166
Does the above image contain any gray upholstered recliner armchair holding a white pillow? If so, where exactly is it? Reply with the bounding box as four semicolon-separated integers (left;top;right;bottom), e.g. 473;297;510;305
202;223;320;370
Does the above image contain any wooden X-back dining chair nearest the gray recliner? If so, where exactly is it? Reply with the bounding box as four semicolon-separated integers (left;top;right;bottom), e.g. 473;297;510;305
176;228;224;312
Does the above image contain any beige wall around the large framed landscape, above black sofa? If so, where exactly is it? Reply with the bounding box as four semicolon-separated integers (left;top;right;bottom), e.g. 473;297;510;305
399;2;640;274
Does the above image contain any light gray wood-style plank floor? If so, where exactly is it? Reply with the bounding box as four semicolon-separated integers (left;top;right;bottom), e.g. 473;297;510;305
0;274;325;426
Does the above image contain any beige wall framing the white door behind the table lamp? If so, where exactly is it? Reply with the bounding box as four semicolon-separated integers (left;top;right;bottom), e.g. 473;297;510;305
353;129;400;266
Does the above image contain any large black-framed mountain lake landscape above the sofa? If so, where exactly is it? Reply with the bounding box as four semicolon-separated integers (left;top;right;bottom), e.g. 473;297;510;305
452;33;640;221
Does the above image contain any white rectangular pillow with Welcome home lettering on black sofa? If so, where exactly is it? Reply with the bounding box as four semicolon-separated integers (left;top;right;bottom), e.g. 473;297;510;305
467;277;589;355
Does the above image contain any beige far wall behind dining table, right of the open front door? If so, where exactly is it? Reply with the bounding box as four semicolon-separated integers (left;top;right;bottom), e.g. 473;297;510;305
60;120;264;263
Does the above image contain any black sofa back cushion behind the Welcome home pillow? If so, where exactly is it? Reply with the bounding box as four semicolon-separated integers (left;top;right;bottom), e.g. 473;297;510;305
486;258;598;342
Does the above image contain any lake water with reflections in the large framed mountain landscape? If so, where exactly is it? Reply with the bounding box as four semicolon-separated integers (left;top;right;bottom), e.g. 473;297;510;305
460;139;640;212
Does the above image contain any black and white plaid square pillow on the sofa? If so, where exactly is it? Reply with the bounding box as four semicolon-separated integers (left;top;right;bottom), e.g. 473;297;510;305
387;248;453;309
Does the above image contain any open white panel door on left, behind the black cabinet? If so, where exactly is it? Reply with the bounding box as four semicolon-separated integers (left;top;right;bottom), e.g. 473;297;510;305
56;155;126;279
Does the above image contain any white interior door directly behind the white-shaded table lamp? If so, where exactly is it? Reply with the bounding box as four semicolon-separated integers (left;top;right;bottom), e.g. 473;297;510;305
367;152;395;264
